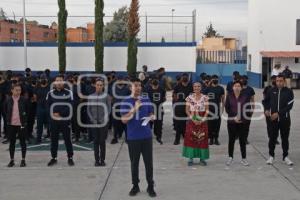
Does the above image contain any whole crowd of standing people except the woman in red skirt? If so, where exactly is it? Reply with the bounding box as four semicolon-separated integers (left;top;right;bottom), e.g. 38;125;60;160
0;66;294;197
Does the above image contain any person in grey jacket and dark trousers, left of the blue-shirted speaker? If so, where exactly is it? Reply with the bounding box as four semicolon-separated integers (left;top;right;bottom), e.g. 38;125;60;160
87;79;111;167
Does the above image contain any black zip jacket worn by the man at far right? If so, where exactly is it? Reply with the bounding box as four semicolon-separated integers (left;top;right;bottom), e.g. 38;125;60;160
263;87;294;120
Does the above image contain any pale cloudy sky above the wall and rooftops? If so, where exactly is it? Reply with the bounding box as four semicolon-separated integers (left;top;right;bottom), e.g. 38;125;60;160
0;0;248;44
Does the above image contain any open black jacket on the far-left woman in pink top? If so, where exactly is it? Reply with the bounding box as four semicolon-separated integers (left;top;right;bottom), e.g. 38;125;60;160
4;96;28;127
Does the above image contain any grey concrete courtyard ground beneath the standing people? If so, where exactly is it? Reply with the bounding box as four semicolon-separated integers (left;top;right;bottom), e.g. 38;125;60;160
0;90;300;200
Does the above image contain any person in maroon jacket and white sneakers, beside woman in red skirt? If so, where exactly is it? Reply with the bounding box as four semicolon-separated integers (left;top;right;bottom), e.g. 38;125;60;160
225;81;249;166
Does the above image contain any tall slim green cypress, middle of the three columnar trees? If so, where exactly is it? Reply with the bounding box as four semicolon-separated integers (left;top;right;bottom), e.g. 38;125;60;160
94;0;104;73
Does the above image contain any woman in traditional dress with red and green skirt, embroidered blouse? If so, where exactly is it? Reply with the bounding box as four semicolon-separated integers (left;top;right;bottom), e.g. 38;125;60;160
182;82;209;166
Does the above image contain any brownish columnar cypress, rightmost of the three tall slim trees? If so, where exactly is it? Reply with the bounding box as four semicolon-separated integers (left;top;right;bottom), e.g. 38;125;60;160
127;0;140;75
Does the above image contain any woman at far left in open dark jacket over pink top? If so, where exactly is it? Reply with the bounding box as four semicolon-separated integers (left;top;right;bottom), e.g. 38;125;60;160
4;84;28;167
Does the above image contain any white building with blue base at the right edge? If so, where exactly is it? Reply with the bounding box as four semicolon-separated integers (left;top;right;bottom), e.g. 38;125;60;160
247;0;300;87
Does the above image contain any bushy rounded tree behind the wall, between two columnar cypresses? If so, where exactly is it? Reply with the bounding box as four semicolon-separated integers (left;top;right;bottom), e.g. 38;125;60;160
104;6;128;42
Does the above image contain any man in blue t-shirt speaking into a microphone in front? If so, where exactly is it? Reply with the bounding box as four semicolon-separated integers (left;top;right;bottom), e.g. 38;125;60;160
121;79;156;197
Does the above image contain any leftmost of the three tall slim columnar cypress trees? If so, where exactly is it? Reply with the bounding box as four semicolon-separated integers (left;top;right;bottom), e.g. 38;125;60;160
58;0;68;72
